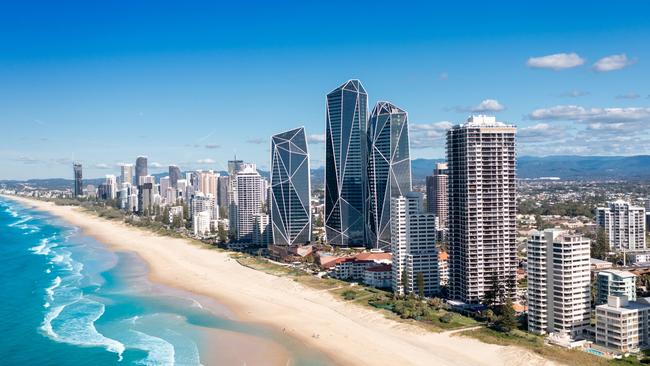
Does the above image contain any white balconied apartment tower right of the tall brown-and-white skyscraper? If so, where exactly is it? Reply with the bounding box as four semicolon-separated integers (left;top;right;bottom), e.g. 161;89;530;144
527;229;591;337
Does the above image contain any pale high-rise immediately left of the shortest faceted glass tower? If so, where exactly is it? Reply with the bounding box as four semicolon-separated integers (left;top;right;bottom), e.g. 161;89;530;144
235;164;262;241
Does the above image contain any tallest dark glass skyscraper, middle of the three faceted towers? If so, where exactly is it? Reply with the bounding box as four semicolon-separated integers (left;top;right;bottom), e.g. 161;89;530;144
325;80;368;246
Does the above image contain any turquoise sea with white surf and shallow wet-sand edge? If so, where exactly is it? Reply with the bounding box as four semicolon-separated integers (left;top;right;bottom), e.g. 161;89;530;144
0;198;331;365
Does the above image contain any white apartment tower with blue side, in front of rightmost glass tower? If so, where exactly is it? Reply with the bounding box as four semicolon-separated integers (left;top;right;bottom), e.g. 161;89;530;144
390;192;440;296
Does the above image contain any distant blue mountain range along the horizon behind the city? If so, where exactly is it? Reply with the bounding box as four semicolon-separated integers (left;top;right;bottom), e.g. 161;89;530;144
0;155;650;189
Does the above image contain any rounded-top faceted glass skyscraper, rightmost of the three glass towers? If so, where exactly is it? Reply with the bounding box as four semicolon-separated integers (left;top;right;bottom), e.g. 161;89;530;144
365;102;411;249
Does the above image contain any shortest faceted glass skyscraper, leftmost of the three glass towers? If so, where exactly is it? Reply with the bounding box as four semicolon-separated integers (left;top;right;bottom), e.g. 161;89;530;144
270;127;311;245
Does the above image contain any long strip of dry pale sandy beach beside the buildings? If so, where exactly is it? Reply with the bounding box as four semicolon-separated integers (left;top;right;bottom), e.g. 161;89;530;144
7;196;554;366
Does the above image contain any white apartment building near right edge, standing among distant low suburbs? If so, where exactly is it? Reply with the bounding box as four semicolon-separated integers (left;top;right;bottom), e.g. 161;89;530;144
596;200;645;250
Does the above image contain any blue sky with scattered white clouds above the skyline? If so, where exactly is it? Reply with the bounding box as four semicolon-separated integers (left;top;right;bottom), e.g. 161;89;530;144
0;0;650;179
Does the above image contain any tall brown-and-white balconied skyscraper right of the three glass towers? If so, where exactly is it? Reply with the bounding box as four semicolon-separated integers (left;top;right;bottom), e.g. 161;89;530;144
447;116;517;303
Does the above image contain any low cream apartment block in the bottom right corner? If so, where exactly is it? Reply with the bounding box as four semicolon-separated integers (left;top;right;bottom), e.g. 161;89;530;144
596;295;650;353
